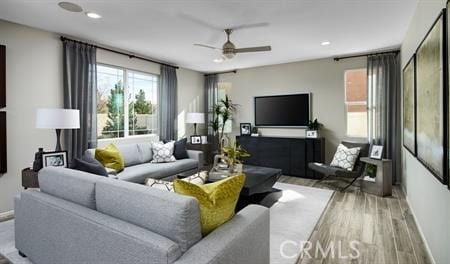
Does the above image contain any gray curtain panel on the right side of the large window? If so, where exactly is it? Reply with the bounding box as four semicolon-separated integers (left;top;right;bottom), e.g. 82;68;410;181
158;65;178;140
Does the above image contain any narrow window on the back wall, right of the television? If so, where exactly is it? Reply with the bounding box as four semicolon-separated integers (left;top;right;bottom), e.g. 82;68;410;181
345;69;367;138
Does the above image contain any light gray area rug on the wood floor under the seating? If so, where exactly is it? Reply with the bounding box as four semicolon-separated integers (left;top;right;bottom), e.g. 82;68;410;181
0;183;333;264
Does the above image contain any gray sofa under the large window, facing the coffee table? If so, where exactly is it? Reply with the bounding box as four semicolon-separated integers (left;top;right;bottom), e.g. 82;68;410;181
85;142;203;183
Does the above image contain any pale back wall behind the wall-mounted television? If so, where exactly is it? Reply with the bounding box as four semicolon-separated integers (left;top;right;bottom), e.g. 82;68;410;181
219;58;366;162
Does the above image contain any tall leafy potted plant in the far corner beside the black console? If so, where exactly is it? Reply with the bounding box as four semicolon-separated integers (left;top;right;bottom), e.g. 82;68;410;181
209;95;237;151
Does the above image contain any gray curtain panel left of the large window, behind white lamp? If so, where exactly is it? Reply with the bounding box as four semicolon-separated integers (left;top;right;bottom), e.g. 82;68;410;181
63;41;97;161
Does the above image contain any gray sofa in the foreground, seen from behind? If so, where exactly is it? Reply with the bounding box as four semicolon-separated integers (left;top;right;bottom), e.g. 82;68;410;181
14;168;270;264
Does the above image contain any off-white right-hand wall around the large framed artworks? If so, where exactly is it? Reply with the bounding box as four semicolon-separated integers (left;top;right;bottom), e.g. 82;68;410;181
401;0;450;263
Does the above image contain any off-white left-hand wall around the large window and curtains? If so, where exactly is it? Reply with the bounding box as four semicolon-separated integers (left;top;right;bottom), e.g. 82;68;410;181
0;20;203;213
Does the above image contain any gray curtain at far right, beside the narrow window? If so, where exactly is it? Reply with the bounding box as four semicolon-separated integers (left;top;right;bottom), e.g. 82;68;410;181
367;53;402;183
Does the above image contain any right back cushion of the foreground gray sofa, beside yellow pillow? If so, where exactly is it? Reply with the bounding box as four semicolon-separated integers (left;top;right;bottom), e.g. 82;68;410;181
95;179;201;252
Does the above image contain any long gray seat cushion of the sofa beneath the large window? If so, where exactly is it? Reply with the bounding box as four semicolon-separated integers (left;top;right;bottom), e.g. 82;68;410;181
117;159;198;183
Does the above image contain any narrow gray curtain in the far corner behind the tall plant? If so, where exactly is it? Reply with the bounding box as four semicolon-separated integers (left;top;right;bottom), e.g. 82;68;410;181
205;74;219;142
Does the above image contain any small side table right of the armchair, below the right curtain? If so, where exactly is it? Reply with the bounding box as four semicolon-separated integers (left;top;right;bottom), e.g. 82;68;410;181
361;157;392;196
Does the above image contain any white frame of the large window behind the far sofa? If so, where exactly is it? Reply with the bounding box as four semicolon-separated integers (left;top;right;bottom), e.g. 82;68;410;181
95;63;160;141
